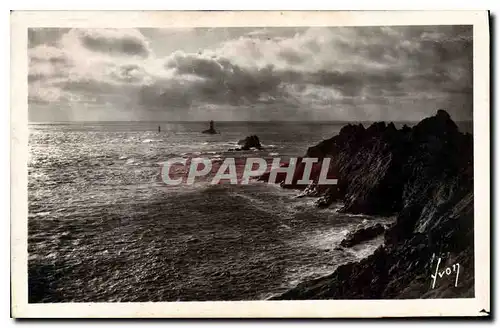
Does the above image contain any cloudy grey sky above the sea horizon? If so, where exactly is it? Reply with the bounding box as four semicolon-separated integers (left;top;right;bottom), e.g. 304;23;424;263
28;25;472;122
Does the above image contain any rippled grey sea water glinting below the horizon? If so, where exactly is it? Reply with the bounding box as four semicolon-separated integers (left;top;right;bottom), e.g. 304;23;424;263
28;122;392;302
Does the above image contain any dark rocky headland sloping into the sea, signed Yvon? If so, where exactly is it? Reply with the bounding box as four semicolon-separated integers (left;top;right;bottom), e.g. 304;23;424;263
270;110;474;300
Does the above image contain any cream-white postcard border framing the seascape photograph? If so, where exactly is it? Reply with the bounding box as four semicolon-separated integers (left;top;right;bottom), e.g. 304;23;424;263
11;11;490;318
